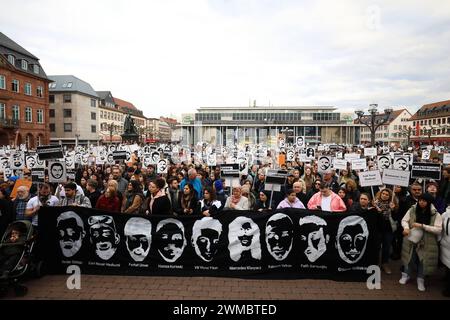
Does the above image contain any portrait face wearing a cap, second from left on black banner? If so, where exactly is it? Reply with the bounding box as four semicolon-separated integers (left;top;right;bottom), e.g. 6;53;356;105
88;215;120;260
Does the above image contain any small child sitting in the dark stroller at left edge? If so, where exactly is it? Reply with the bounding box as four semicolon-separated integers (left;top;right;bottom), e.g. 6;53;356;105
0;225;25;279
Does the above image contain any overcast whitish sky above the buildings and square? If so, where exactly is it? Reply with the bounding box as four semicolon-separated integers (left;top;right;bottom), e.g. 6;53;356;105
0;0;450;117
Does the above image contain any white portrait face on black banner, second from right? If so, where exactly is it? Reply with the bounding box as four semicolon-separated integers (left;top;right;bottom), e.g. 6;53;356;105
299;216;330;263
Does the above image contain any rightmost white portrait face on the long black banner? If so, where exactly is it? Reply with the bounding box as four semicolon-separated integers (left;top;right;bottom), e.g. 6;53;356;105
336;216;369;264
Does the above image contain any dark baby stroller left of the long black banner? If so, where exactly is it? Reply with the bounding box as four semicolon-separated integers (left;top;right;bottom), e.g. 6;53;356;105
0;220;42;297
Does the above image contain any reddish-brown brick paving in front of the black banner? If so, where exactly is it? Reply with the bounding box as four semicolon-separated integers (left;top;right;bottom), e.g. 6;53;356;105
6;262;448;300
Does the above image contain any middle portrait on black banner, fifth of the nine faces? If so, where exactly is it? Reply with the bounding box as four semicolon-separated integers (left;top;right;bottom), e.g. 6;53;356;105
191;217;222;262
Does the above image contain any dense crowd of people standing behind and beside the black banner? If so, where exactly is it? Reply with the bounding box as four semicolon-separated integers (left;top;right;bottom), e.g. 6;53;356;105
0;144;450;296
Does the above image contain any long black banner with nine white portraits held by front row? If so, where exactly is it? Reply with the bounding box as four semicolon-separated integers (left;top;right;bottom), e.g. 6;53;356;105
39;207;378;280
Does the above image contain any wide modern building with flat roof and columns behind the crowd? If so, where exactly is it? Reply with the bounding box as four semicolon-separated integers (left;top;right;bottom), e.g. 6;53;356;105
179;106;360;146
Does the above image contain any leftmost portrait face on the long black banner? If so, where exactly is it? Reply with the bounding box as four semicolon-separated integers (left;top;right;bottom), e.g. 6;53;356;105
56;211;86;258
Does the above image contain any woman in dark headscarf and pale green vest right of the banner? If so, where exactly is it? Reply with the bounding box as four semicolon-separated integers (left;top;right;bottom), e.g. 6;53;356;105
399;193;442;291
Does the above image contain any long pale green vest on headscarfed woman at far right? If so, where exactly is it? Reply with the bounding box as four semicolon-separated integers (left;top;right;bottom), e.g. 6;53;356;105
402;205;439;276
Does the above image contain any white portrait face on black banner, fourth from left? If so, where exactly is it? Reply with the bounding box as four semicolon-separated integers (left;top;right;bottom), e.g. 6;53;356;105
156;218;187;262
